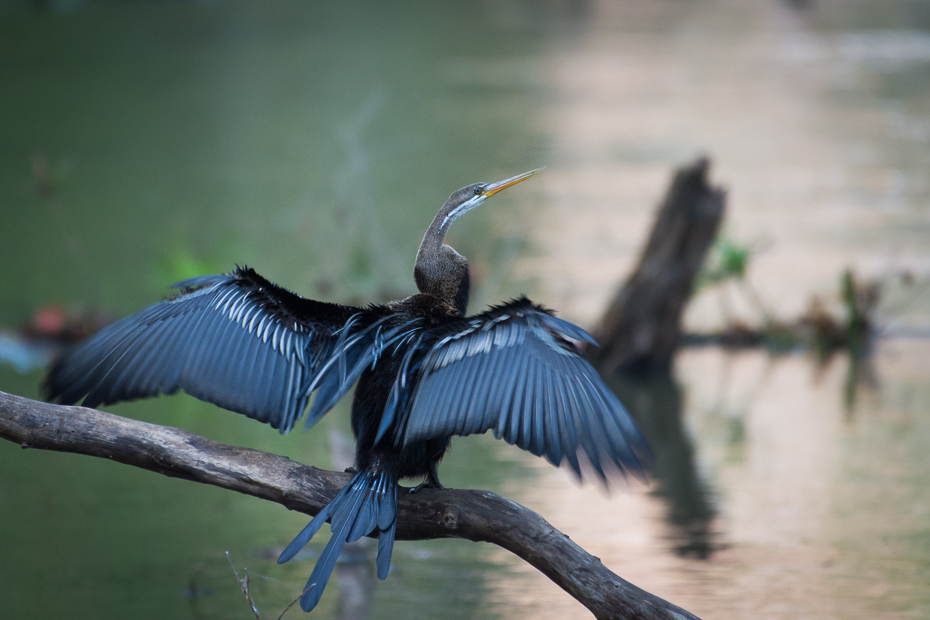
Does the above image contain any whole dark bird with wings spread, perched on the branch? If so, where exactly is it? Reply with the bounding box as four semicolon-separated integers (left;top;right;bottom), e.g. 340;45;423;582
46;170;645;611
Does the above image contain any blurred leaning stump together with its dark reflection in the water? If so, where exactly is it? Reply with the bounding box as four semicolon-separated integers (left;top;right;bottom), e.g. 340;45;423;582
587;158;725;559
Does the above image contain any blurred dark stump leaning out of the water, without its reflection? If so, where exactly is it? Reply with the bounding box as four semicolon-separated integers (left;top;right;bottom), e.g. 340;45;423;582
589;158;725;372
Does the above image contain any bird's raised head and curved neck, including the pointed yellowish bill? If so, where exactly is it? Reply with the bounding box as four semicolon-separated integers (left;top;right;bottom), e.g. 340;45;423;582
413;168;543;314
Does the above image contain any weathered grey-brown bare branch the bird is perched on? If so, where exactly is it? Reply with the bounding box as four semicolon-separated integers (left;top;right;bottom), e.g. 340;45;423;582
0;392;695;620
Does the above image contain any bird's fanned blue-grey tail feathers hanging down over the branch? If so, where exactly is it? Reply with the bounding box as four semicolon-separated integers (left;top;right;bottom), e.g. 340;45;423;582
278;471;397;611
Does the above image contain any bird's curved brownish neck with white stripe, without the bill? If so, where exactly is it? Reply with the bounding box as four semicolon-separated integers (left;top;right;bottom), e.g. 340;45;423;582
413;200;471;315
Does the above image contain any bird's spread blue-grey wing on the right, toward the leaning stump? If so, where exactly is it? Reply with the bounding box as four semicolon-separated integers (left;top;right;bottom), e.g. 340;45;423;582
395;299;648;481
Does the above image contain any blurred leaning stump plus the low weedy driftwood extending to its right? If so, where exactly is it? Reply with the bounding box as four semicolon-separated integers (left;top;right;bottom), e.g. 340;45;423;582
588;158;876;364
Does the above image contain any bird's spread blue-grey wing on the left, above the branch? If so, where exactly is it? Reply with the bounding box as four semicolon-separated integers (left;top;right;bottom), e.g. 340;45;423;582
45;268;398;433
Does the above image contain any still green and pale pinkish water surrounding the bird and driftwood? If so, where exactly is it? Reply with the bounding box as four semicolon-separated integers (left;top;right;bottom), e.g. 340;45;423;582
0;0;930;619
